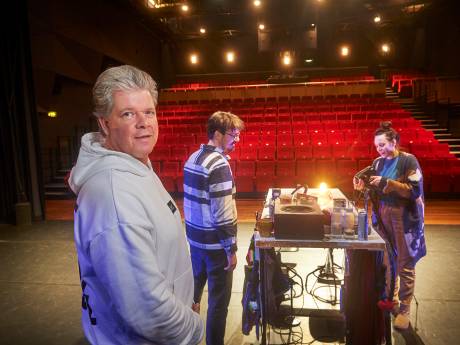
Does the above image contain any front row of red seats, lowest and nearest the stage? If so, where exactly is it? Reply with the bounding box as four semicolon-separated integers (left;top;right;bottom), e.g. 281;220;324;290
154;159;460;193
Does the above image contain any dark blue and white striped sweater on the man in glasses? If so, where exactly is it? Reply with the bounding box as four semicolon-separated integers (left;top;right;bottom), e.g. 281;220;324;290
184;145;237;252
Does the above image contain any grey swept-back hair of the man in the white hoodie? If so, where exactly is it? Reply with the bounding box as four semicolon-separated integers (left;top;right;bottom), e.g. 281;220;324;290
93;65;158;118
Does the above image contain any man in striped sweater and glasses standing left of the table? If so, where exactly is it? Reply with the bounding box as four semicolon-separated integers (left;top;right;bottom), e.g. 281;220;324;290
184;111;244;345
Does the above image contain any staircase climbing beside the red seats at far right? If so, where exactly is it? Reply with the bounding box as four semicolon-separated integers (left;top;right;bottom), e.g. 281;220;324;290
385;87;460;158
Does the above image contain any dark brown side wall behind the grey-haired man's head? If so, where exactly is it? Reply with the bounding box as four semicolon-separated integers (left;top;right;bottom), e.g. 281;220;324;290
29;0;164;172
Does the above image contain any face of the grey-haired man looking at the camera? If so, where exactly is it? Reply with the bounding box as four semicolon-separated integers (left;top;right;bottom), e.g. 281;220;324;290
98;90;158;164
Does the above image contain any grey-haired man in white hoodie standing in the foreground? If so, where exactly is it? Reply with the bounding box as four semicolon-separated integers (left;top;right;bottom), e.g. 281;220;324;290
69;66;203;345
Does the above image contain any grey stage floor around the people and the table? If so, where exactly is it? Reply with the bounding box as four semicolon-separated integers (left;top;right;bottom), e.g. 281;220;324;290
0;221;460;345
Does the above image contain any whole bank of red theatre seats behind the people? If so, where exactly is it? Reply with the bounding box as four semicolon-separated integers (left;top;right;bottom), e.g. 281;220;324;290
150;97;460;195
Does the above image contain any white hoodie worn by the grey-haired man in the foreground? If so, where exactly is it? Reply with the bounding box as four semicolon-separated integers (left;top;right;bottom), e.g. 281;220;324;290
69;133;203;345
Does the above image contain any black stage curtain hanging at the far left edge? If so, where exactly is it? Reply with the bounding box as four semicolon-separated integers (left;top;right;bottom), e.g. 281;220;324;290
0;0;44;223
